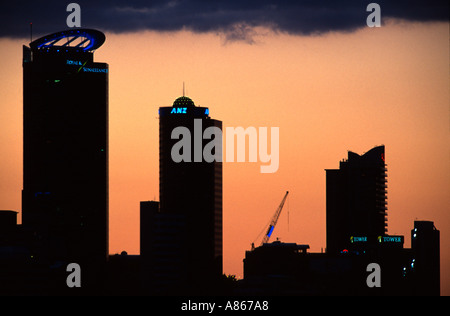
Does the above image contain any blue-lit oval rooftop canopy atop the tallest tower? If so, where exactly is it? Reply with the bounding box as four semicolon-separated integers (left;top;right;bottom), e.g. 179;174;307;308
30;29;105;52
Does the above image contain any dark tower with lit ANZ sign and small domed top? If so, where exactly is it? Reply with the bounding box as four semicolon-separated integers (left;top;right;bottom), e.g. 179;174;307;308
159;96;222;277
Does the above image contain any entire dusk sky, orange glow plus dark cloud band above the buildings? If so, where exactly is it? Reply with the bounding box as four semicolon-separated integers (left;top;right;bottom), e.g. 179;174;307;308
0;1;450;295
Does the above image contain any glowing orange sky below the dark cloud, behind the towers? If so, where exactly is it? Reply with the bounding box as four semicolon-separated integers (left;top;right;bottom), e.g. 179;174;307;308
0;8;449;294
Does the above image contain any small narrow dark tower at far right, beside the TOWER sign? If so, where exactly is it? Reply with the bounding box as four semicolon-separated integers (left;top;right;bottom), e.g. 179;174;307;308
408;221;441;296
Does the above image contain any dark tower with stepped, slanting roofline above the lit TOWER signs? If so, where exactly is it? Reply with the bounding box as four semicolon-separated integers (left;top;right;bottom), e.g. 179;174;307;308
326;146;387;253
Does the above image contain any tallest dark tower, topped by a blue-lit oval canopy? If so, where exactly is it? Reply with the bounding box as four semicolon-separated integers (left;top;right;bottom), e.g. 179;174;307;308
22;29;108;278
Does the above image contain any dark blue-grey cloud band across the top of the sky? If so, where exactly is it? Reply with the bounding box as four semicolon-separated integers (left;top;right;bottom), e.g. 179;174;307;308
0;0;449;41
